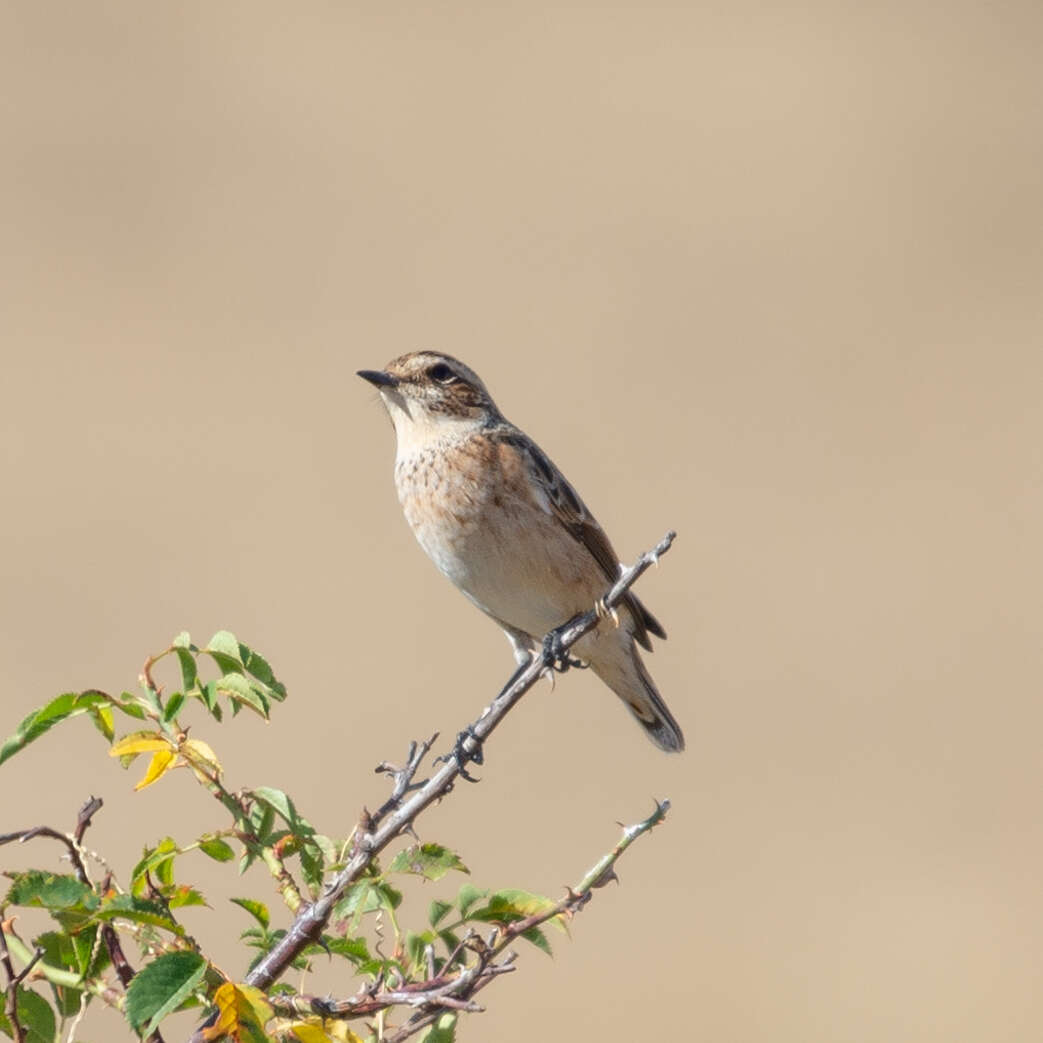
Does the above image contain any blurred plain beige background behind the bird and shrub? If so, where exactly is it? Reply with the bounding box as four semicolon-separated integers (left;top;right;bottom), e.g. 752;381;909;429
0;0;1043;1043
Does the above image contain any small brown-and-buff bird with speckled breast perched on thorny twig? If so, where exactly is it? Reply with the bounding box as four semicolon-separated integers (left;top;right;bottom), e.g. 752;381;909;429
358;351;684;752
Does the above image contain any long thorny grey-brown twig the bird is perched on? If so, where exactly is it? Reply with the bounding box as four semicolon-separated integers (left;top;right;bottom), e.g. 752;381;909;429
239;532;676;990
